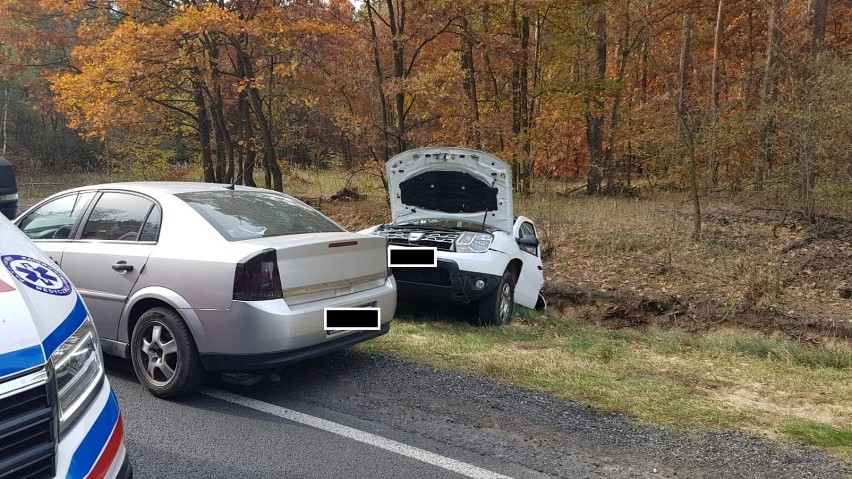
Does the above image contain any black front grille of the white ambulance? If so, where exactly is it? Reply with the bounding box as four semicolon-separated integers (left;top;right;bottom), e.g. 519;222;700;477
0;370;57;479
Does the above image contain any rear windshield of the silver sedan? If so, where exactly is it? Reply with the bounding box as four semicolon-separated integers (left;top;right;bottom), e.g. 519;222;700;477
175;190;345;241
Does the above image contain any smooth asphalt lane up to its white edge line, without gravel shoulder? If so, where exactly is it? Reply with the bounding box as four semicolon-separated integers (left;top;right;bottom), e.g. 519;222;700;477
107;358;546;479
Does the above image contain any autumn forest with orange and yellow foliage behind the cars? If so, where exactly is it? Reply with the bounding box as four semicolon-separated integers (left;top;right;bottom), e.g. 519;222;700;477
0;0;852;221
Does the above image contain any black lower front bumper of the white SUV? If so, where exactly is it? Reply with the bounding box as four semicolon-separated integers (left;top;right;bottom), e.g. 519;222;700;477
393;258;502;304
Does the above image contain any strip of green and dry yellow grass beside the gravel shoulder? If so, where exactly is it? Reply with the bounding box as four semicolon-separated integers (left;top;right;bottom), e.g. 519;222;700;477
360;307;852;462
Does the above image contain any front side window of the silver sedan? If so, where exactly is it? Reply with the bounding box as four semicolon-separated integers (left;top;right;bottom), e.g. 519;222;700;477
18;191;95;239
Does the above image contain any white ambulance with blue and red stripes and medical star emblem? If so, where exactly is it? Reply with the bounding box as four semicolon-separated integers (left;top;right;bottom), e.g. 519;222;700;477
0;215;133;479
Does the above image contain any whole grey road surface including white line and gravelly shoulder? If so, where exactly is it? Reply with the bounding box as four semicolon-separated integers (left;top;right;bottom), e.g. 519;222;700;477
107;350;852;479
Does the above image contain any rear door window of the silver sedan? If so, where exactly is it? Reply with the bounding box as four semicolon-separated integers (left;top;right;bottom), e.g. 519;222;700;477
81;192;152;241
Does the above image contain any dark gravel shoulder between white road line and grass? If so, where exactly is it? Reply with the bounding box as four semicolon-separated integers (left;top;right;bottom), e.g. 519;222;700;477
232;350;852;478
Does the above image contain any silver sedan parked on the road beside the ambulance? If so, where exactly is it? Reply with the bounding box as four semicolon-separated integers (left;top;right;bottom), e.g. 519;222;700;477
15;182;396;397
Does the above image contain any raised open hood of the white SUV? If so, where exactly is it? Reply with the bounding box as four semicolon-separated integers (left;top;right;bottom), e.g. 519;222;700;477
385;147;513;231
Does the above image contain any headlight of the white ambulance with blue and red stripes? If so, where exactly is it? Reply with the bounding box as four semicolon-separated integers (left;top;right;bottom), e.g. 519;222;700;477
51;318;104;436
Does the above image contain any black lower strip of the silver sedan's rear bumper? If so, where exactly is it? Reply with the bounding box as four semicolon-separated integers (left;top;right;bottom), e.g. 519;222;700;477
200;323;390;371
